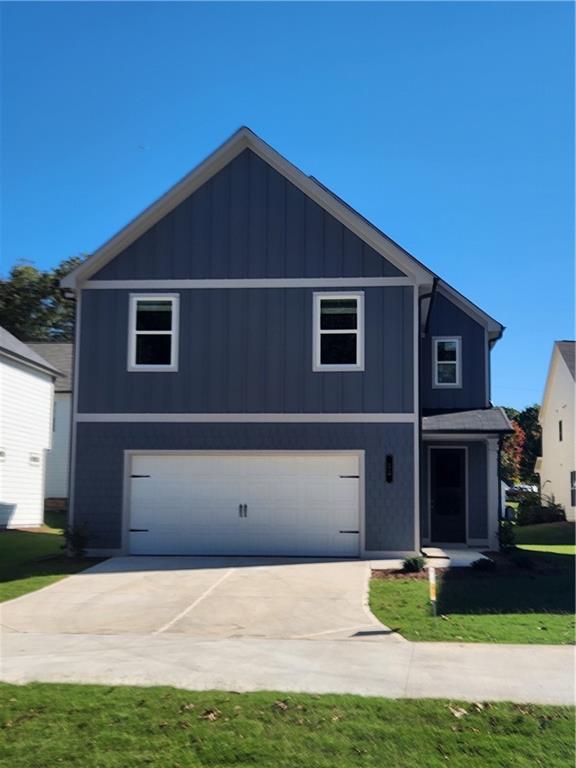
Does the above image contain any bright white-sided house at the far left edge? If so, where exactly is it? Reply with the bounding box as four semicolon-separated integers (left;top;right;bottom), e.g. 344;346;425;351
0;328;58;528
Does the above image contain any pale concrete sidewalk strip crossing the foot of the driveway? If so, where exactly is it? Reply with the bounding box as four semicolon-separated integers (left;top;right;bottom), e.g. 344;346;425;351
0;633;574;704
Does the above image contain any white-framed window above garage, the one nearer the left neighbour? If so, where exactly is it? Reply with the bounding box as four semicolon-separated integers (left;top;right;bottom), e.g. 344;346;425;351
128;293;179;372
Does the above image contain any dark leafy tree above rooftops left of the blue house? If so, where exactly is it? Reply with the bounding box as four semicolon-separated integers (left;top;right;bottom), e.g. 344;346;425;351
0;256;85;341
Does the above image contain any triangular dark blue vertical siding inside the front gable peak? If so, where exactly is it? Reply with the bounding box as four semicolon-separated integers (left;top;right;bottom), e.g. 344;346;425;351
90;149;403;280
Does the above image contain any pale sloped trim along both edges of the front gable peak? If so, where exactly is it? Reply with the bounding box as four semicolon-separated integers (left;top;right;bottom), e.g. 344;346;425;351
61;127;433;289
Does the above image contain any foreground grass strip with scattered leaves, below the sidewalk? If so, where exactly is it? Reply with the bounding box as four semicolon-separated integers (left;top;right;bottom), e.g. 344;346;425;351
0;684;574;768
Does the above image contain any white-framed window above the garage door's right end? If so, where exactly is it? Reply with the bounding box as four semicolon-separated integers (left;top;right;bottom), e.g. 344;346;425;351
312;292;364;371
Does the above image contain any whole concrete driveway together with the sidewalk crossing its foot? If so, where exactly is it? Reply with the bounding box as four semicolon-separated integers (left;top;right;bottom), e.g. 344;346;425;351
0;558;574;704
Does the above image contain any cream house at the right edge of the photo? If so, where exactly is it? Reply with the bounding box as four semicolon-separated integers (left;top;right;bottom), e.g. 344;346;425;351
536;341;576;520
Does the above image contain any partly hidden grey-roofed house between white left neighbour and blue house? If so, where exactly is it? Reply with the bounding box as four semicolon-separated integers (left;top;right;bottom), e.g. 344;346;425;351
28;342;73;509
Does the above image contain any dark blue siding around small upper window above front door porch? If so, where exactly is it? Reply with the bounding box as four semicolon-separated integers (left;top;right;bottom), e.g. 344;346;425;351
421;293;489;411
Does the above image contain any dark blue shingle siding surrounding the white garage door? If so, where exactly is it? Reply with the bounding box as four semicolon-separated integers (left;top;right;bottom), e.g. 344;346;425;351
74;423;415;552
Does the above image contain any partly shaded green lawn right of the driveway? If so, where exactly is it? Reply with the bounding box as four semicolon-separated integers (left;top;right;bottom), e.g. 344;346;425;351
370;523;575;644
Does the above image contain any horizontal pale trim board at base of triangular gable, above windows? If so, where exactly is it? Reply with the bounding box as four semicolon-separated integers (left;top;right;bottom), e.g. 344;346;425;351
82;277;414;291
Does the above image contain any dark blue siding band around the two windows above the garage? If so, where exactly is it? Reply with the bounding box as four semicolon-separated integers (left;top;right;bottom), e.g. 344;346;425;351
78;286;414;413
